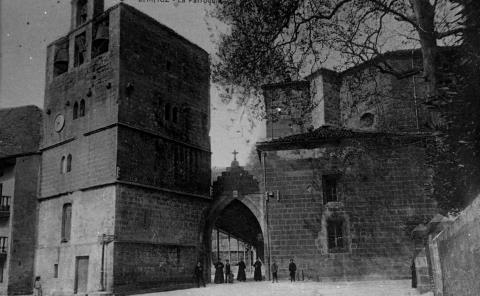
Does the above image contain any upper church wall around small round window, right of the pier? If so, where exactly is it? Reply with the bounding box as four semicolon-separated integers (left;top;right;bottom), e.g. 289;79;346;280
340;57;431;132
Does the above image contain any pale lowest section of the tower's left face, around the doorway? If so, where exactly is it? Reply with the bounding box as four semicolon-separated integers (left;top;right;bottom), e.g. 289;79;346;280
35;186;116;295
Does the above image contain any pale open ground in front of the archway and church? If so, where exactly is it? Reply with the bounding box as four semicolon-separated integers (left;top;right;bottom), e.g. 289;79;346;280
144;281;428;296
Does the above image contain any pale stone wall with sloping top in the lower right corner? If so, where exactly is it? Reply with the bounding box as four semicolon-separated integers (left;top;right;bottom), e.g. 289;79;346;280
434;197;480;296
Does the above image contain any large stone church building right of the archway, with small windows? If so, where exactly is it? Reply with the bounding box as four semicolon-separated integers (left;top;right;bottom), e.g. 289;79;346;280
257;52;437;280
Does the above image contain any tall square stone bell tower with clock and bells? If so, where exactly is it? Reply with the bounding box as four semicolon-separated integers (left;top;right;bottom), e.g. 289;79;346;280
35;0;210;295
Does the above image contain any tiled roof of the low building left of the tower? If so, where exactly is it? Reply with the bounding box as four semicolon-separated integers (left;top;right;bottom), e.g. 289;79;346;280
0;106;42;158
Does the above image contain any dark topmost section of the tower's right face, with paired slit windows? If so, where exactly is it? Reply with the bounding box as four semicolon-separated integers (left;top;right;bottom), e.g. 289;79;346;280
119;5;210;151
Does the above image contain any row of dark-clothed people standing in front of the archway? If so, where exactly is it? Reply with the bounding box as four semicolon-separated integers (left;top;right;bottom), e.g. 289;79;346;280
195;258;297;287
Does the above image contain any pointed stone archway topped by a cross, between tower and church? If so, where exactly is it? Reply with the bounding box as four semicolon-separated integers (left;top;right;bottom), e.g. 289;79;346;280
203;152;268;279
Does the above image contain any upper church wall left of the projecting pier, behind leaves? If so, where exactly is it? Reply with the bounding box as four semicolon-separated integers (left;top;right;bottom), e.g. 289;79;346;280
263;81;312;138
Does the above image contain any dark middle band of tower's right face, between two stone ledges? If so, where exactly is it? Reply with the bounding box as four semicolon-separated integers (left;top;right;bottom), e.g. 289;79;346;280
117;128;210;196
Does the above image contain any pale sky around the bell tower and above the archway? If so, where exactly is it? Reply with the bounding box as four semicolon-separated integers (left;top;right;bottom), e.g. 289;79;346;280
0;0;262;166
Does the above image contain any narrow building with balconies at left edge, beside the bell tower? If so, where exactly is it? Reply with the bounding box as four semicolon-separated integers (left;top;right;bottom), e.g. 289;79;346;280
0;106;42;295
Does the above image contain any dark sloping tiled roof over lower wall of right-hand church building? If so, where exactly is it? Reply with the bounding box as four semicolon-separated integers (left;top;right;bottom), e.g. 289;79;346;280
257;126;430;151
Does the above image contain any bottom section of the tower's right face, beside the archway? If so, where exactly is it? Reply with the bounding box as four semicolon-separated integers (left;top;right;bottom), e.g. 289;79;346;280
114;185;210;291
